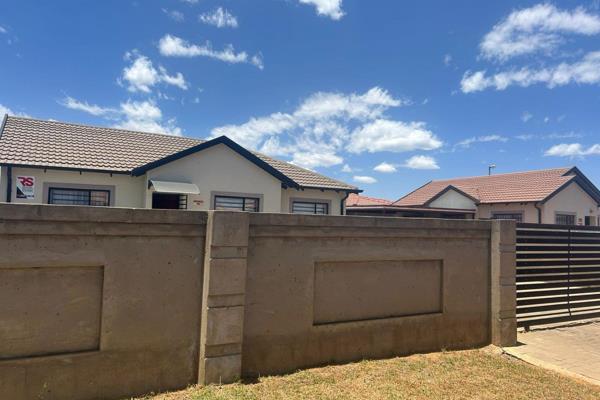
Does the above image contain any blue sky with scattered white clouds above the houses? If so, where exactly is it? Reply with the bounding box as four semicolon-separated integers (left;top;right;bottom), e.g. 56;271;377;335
0;0;600;199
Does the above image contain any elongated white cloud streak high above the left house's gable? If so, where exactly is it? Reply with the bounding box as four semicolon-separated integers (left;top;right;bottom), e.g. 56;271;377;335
158;34;264;69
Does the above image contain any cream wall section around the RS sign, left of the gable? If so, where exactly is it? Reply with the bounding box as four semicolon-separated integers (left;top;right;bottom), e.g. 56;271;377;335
2;168;145;208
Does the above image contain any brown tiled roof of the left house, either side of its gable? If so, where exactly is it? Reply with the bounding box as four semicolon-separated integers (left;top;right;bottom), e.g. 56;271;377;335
0;116;357;190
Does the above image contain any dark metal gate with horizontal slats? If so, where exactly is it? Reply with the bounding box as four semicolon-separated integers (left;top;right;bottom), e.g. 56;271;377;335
517;223;600;327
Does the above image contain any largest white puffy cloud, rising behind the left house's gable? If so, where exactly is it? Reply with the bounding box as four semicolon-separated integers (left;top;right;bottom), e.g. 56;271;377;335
211;87;442;168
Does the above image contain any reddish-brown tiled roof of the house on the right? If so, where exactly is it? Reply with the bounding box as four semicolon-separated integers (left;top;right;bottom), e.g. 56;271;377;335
394;168;576;206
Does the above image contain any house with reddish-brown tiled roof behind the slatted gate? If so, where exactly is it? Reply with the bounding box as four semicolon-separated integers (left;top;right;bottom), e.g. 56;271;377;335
392;167;600;225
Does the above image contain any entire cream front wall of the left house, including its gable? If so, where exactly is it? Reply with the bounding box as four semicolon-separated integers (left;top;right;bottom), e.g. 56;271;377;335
0;144;346;215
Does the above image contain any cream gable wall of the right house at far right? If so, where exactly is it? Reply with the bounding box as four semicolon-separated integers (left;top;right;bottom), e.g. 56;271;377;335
543;182;598;225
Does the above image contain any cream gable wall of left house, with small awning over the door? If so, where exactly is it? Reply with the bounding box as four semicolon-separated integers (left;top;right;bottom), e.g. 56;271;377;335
144;144;281;212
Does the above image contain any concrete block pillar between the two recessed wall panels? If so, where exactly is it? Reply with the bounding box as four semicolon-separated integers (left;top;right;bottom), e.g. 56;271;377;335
198;211;248;385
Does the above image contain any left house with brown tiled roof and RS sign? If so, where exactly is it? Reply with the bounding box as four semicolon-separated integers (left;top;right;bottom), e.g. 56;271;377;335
0;116;360;215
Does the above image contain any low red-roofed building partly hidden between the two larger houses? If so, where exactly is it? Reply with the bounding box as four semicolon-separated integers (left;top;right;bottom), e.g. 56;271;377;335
346;193;475;219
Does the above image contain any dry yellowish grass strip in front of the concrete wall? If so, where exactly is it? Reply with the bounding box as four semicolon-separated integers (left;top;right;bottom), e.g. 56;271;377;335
135;347;600;400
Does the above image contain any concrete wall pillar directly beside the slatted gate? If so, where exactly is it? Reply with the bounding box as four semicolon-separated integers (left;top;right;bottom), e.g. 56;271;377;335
490;220;517;346
